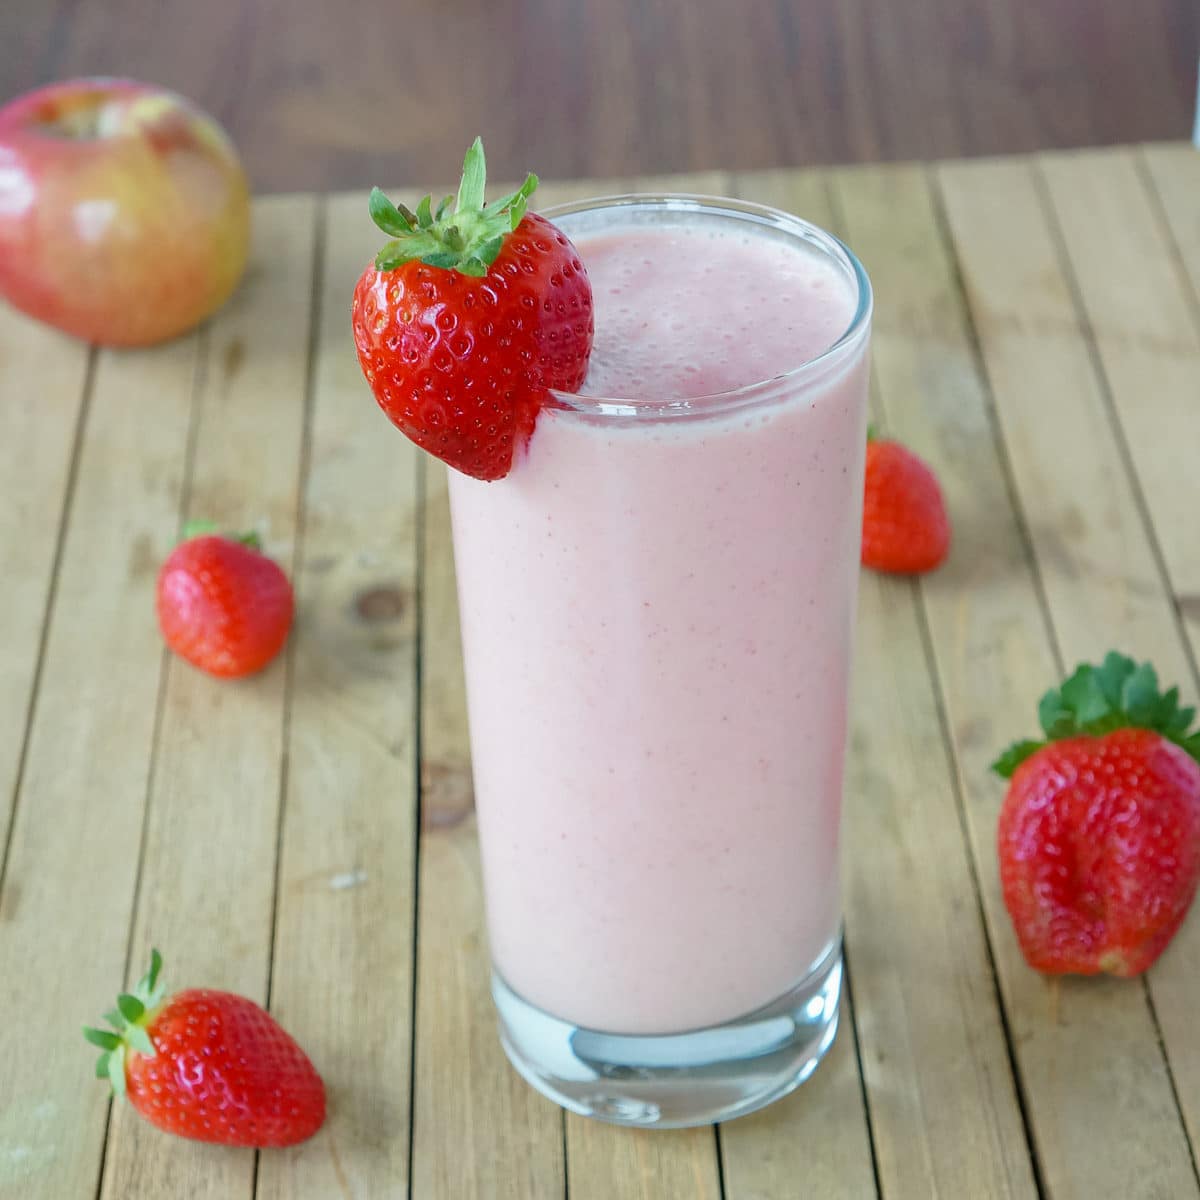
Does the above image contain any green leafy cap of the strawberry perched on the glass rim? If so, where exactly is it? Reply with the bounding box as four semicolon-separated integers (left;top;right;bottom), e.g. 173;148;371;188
370;138;538;278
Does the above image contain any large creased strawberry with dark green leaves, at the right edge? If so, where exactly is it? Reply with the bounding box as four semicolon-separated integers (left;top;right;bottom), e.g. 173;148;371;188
992;653;1200;976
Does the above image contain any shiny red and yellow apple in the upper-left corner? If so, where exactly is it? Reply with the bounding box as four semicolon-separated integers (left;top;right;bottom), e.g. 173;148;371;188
0;79;250;346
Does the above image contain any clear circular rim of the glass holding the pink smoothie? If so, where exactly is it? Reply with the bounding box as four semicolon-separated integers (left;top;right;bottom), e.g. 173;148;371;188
540;192;874;420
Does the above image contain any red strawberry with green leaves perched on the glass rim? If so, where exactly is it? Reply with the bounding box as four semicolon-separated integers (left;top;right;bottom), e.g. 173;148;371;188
353;138;593;480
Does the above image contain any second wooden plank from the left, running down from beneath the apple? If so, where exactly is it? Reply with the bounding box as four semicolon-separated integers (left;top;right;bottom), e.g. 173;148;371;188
0;330;197;1200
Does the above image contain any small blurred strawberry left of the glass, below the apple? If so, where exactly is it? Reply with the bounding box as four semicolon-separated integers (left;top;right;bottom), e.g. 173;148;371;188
157;523;293;677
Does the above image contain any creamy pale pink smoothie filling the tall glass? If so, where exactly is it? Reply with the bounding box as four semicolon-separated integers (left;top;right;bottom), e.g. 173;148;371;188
450;204;866;1033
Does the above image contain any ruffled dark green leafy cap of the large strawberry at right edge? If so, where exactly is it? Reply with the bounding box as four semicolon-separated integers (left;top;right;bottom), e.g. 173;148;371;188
991;650;1200;779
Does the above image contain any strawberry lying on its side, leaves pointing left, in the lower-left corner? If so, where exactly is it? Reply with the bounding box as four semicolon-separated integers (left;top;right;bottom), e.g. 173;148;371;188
83;950;325;1148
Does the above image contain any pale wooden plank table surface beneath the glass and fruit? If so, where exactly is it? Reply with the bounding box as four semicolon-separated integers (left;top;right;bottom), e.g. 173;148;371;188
0;145;1200;1200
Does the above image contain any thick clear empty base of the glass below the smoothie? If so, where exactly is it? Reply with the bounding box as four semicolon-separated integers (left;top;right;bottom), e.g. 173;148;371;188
492;938;841;1129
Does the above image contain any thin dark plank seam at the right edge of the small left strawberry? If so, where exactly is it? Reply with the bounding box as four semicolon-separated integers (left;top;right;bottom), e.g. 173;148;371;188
251;196;326;1196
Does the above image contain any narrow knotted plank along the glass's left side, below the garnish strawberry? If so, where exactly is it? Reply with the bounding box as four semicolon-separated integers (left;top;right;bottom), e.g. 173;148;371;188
408;460;565;1200
